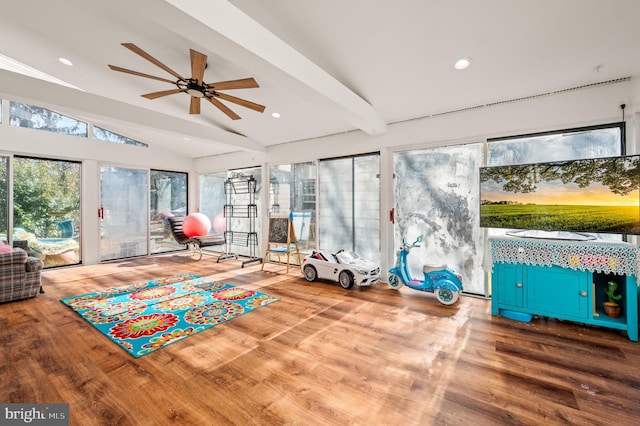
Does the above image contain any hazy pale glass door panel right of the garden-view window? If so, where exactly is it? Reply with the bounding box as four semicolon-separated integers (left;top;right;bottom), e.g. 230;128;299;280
100;166;149;261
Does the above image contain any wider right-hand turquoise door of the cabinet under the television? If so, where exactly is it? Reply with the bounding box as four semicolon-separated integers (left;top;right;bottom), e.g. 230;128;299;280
524;266;590;318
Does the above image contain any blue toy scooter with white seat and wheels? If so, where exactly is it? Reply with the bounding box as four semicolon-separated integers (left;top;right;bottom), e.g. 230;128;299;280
389;236;462;305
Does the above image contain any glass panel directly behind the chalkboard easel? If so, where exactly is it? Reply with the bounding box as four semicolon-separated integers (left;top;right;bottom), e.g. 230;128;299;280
269;162;316;251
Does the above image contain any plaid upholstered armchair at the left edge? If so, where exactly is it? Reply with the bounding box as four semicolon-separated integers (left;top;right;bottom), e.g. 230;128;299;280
0;248;44;303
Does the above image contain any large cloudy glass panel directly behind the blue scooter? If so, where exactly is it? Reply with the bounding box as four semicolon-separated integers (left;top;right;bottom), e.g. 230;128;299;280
394;143;485;295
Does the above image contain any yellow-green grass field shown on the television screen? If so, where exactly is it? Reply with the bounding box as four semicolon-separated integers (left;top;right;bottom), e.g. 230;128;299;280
480;204;640;234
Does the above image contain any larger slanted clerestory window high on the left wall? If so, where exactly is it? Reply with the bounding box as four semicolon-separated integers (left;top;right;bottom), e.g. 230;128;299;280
9;101;87;137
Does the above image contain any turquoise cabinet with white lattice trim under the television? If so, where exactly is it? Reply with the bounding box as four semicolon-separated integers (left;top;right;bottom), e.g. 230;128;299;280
490;240;638;341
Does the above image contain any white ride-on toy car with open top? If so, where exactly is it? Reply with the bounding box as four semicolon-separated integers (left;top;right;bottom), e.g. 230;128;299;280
300;250;380;288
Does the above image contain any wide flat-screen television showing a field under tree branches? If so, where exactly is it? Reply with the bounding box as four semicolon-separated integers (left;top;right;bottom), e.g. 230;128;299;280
480;155;640;234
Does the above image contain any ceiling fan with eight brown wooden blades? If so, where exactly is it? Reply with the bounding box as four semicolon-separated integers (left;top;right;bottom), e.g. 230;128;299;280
109;43;265;120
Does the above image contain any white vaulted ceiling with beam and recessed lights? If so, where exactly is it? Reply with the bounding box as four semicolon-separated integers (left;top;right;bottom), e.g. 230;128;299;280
0;0;640;158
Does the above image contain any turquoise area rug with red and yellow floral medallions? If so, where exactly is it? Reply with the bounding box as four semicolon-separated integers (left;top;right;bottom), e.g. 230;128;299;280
61;274;279;358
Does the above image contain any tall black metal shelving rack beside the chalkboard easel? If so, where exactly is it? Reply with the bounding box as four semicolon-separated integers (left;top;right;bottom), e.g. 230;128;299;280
218;174;262;267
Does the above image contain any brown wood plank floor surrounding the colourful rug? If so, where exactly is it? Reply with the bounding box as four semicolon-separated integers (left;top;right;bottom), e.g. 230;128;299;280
0;254;640;426
